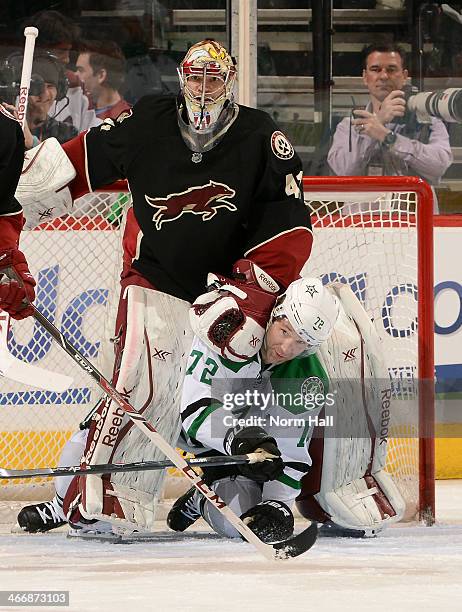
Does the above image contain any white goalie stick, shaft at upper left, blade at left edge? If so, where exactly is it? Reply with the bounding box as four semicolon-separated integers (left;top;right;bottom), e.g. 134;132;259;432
0;27;72;393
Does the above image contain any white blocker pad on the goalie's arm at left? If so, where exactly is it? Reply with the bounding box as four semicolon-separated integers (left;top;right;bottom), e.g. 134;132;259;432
15;138;76;229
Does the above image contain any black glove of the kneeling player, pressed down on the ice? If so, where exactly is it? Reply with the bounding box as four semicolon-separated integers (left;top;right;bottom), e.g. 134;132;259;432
241;499;294;544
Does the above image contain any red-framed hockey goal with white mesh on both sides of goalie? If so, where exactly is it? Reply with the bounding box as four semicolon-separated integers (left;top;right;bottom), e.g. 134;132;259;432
0;177;434;523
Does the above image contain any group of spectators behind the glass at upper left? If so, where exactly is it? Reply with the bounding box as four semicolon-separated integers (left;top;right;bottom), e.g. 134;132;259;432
0;11;139;149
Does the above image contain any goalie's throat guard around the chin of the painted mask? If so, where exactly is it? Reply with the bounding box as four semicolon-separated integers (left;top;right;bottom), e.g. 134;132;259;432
177;96;239;153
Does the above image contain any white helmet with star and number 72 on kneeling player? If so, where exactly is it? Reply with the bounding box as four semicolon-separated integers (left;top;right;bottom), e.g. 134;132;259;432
271;277;339;348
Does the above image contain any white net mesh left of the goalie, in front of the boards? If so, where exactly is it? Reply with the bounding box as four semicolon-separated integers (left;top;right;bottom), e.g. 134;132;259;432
0;193;124;499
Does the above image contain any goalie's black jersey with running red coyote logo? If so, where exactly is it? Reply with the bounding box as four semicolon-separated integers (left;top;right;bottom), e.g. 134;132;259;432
64;96;312;301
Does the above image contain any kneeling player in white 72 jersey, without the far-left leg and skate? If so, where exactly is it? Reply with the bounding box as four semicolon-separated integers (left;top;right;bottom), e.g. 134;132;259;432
167;278;339;542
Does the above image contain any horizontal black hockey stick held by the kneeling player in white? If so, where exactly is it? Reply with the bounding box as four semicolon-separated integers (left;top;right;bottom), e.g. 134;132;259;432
0;453;309;480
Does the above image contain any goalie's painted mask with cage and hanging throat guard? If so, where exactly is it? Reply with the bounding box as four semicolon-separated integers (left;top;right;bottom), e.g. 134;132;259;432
178;40;238;152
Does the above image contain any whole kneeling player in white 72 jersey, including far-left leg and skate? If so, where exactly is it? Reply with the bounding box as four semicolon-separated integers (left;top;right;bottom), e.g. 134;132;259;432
18;278;338;539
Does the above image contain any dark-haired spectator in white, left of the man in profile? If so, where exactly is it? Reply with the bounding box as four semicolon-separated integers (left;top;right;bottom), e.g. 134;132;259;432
25;10;101;132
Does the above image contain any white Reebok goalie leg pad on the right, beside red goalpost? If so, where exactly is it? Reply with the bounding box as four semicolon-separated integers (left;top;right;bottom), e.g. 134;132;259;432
300;284;405;531
